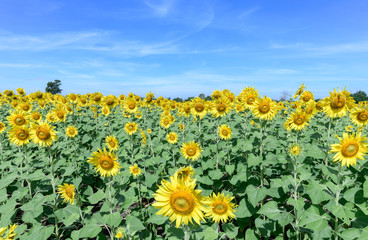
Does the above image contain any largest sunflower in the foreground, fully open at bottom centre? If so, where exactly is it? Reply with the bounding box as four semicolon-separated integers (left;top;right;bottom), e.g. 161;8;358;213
152;177;205;228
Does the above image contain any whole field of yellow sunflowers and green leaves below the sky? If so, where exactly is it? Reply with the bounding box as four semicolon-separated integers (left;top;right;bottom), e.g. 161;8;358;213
0;85;368;240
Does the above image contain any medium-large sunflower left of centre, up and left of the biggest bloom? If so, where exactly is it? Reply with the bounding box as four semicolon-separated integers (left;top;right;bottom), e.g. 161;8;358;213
87;148;121;177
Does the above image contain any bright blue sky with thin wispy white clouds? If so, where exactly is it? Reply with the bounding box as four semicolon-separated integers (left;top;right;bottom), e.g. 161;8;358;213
0;0;368;99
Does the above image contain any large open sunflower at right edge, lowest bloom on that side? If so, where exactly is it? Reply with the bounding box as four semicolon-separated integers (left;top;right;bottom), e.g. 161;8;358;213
330;133;368;167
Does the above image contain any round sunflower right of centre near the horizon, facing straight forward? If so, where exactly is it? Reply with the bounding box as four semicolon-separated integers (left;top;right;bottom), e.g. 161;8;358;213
251;96;277;120
